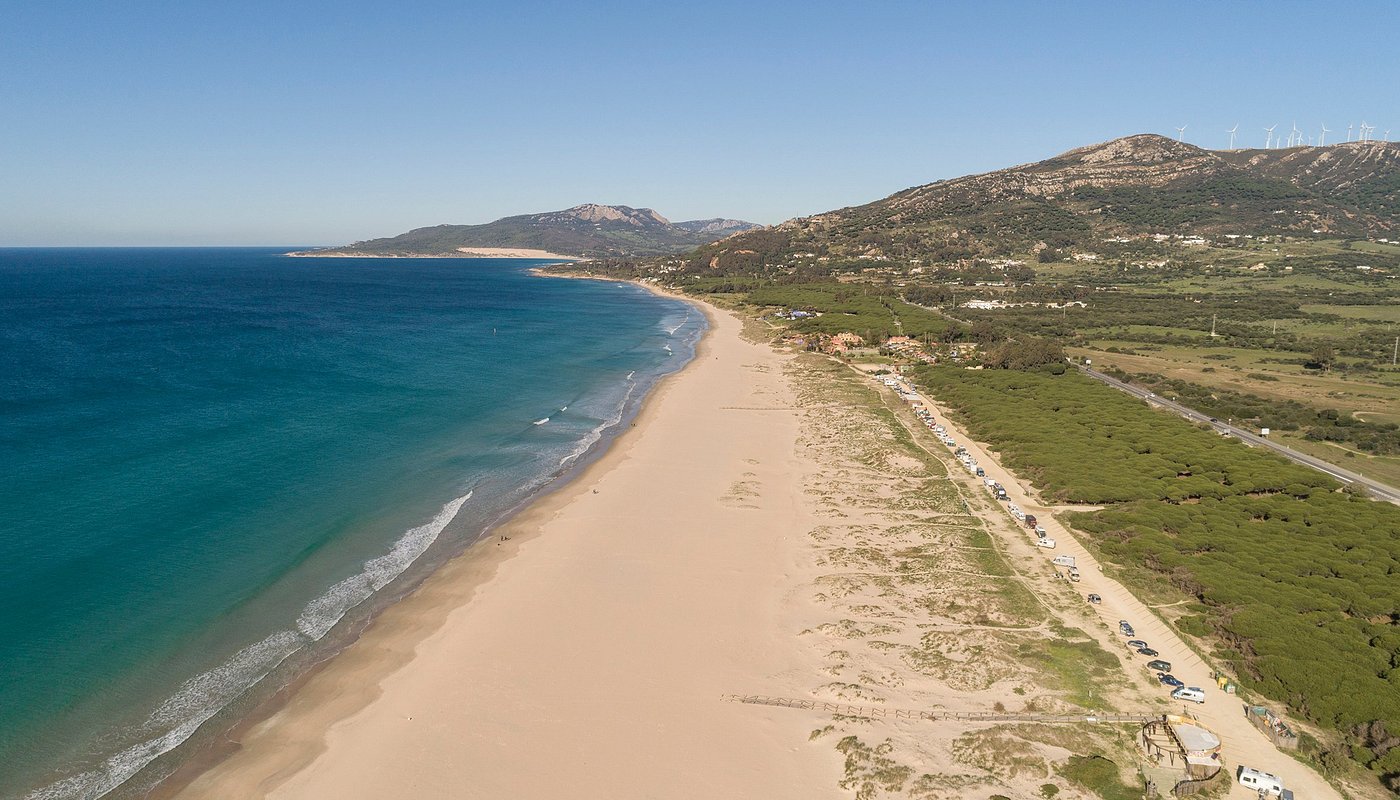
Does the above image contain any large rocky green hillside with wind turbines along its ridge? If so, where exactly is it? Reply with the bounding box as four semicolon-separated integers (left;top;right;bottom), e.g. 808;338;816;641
674;135;1400;273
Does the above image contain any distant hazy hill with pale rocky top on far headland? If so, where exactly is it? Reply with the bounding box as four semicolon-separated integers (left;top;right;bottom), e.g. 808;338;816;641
289;203;759;258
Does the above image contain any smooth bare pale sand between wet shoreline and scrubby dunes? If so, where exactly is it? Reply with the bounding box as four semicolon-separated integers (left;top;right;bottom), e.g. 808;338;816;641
181;304;846;800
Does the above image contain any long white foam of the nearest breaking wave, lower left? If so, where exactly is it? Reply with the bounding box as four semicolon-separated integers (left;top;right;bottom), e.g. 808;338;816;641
25;492;472;800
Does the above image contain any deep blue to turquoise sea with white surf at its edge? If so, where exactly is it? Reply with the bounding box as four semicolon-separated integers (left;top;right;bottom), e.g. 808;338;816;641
0;248;704;797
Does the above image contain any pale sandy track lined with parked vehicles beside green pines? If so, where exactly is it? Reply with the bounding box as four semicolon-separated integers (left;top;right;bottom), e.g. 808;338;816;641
920;383;1341;800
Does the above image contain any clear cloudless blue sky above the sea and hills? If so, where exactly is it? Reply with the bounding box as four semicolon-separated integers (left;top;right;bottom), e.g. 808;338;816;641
0;0;1400;247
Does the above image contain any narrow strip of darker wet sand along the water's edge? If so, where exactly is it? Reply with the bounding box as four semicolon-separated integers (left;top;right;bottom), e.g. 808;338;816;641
163;280;715;799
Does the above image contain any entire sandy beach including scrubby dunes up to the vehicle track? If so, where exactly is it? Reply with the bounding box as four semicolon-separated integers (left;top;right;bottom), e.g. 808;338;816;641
169;295;1336;800
